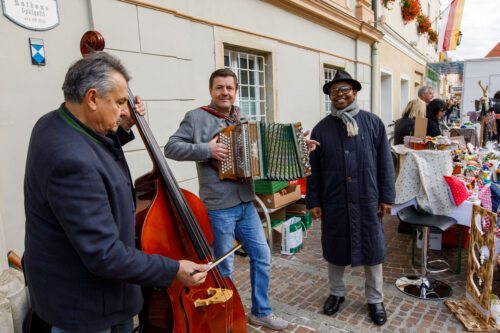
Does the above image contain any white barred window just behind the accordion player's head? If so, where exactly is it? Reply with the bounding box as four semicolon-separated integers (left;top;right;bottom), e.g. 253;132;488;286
224;49;267;121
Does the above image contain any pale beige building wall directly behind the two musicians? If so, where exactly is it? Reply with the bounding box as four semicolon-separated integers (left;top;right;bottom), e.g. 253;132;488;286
0;0;383;266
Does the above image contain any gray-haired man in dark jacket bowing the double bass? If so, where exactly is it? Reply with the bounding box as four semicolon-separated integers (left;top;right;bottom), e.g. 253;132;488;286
24;52;208;333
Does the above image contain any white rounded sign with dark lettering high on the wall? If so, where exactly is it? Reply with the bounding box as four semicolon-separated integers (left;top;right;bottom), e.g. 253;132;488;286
2;0;59;30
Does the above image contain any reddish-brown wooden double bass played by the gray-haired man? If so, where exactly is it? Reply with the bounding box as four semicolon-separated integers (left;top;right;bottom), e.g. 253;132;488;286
80;31;246;333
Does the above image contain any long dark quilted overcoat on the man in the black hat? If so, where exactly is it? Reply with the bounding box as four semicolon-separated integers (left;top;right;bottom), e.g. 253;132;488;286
306;110;395;266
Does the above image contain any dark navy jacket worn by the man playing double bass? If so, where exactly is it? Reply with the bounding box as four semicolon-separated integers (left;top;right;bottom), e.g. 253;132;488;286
24;106;178;332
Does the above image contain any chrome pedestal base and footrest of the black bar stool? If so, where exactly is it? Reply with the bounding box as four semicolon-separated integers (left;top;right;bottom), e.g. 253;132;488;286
396;226;452;300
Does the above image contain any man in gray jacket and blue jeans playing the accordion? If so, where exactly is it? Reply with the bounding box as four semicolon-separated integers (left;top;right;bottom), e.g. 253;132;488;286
165;69;288;330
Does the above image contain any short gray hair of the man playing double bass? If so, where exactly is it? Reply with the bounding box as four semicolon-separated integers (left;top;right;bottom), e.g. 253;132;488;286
62;52;130;103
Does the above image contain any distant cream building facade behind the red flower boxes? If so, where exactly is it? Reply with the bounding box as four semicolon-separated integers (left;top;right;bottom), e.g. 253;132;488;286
376;0;441;124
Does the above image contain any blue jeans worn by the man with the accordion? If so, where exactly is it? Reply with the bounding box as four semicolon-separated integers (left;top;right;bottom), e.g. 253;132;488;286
208;202;271;317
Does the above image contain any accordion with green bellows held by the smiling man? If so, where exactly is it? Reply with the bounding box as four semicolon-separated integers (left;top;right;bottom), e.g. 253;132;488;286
219;122;311;180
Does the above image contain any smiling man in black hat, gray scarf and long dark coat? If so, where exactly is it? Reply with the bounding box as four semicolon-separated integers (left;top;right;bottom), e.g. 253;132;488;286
306;70;395;325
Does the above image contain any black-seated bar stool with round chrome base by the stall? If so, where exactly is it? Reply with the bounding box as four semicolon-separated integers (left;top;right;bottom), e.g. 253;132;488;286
396;206;457;300
